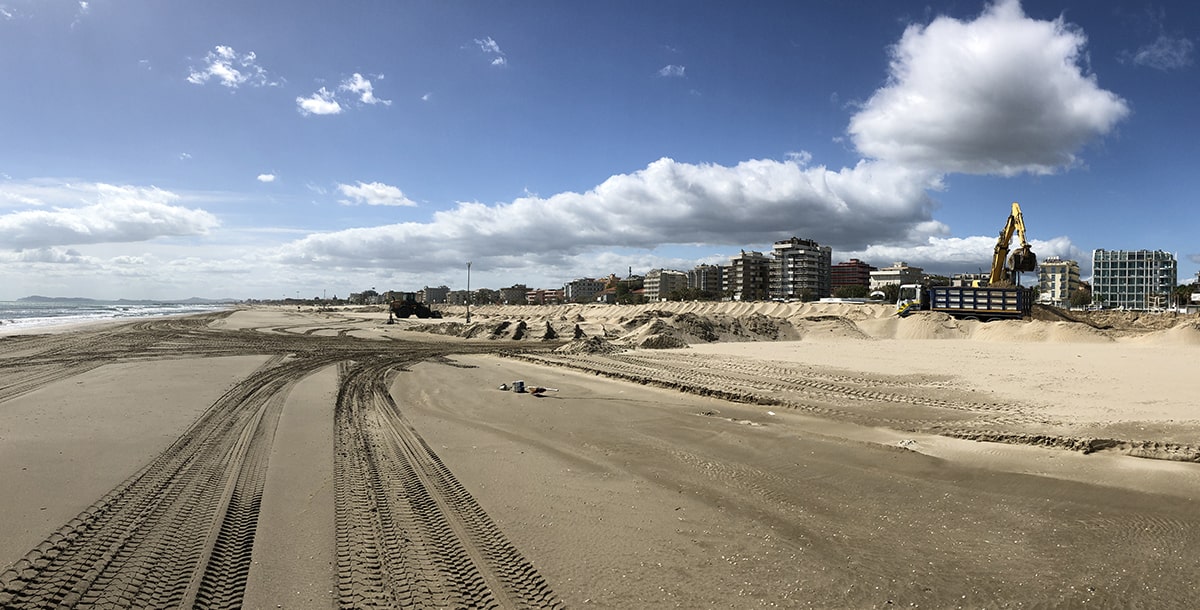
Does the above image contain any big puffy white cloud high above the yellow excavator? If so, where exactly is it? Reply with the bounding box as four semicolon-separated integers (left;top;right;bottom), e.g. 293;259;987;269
848;0;1130;175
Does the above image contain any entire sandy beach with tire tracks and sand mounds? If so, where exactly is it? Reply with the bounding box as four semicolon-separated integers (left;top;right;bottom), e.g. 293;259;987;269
0;304;1200;608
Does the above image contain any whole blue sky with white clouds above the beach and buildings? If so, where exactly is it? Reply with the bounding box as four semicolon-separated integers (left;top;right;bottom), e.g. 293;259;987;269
0;0;1200;300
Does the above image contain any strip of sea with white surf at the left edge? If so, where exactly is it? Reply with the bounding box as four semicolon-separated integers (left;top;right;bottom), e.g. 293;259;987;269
0;300;232;333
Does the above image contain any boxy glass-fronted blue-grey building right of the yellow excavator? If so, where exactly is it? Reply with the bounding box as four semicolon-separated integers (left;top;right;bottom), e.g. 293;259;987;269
1092;250;1178;310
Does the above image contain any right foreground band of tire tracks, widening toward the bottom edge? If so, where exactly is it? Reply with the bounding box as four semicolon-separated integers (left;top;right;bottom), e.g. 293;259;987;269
335;363;562;608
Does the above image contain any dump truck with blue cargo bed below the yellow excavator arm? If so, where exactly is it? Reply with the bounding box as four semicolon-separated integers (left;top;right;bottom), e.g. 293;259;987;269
896;283;1033;322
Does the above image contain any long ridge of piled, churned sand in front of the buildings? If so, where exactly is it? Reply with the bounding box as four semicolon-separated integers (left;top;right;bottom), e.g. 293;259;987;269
398;301;1200;348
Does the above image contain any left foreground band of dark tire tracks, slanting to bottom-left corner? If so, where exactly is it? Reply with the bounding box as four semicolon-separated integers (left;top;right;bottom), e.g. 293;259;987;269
0;357;328;608
